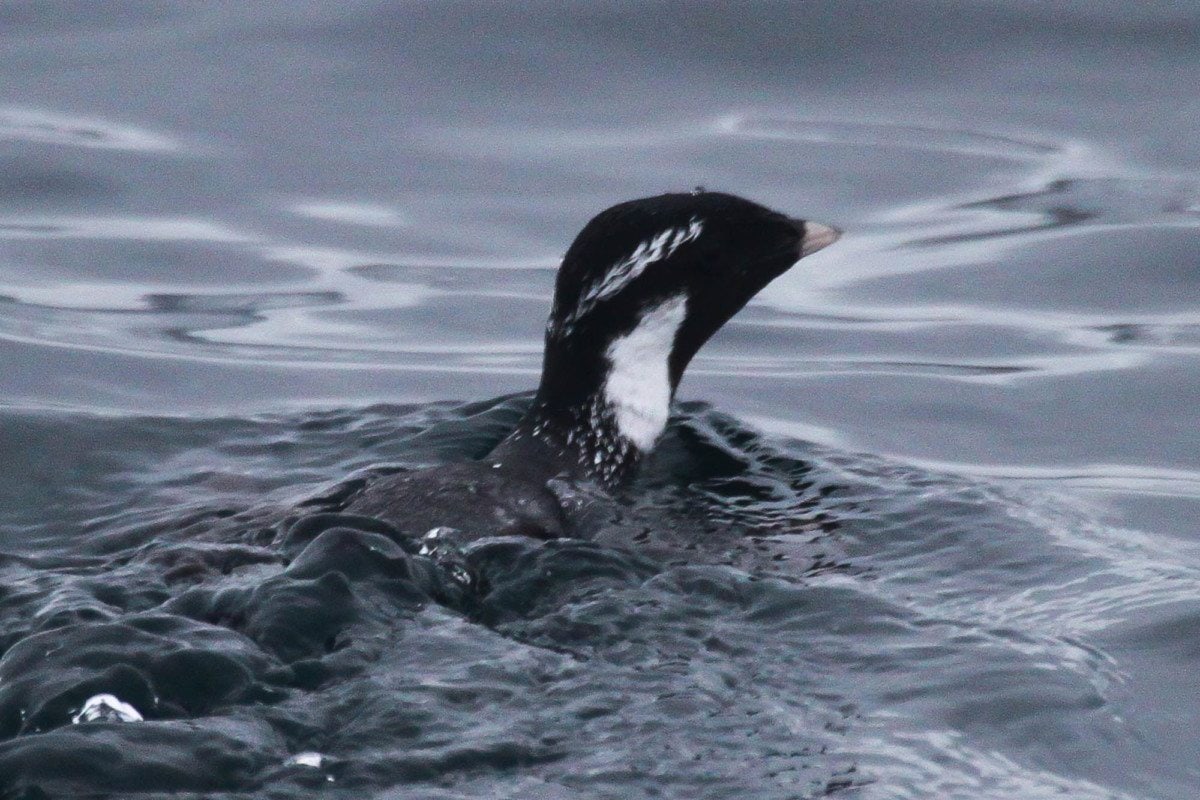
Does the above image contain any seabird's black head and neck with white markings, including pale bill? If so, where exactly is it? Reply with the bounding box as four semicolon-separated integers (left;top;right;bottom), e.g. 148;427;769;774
504;192;838;484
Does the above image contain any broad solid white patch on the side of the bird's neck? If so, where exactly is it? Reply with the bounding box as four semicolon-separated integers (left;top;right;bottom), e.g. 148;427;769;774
604;295;688;452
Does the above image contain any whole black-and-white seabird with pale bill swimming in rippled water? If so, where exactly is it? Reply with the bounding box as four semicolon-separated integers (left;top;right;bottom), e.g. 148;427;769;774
344;191;840;539
